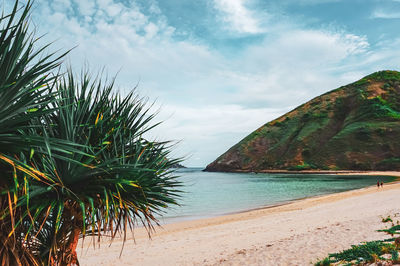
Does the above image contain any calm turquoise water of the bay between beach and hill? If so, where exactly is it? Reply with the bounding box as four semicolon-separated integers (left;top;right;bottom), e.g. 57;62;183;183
161;168;394;222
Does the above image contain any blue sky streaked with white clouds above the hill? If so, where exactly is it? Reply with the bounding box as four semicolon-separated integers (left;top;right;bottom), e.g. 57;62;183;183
7;0;400;167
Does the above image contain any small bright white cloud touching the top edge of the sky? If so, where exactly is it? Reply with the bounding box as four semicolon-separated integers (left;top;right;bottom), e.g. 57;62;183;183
214;0;264;34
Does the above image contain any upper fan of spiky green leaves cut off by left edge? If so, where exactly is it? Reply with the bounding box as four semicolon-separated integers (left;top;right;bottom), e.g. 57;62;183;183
0;1;65;154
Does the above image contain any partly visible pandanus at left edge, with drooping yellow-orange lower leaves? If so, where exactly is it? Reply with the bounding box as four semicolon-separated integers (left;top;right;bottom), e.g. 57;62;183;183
0;1;67;265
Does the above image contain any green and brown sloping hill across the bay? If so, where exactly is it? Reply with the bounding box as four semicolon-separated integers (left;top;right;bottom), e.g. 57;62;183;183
205;71;400;172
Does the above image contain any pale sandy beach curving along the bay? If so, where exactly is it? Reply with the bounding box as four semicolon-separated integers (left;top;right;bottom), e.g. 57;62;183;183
78;172;400;265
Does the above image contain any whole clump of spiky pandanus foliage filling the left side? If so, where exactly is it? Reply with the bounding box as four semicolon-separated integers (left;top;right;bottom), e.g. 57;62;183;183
0;2;179;265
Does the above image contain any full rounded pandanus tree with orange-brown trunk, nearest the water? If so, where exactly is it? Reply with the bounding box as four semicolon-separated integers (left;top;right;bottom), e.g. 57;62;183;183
30;70;179;265
